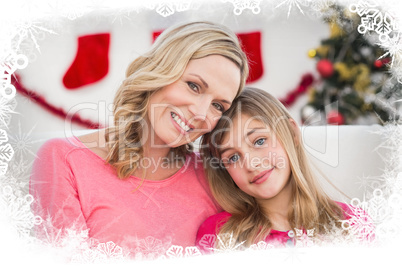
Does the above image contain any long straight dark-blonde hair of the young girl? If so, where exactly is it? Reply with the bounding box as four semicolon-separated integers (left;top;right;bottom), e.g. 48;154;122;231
200;88;343;246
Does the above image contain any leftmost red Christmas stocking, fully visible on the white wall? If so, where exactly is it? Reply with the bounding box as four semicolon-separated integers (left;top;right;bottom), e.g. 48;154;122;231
63;33;110;89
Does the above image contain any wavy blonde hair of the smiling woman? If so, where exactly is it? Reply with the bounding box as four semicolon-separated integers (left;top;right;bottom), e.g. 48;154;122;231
105;22;249;178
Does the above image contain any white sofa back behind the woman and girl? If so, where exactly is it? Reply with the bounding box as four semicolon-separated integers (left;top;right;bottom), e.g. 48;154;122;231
28;125;385;202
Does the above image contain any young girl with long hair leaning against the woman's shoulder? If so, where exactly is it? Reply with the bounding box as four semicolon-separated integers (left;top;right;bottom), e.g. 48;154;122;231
196;88;374;252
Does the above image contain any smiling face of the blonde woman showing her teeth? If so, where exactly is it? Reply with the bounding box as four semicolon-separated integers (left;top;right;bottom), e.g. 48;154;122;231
148;55;241;147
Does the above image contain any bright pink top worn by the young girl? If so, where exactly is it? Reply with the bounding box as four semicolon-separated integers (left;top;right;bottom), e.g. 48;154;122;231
196;202;375;253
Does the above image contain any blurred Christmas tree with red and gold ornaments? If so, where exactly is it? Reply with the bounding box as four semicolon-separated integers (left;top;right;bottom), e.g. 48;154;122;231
301;5;402;125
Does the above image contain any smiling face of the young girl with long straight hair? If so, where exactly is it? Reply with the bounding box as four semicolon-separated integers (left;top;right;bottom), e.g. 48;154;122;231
218;114;291;203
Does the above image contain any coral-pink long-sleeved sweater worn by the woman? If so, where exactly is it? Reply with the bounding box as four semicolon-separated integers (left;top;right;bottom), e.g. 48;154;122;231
30;137;219;251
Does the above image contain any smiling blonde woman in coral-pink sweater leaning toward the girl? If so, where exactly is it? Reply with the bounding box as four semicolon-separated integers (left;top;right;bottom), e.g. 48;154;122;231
30;22;248;253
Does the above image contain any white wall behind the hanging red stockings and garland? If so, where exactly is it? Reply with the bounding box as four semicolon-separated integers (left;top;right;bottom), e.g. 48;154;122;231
10;2;329;136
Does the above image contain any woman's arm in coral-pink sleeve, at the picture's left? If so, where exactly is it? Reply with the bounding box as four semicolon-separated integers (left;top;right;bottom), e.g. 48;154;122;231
29;139;87;238
